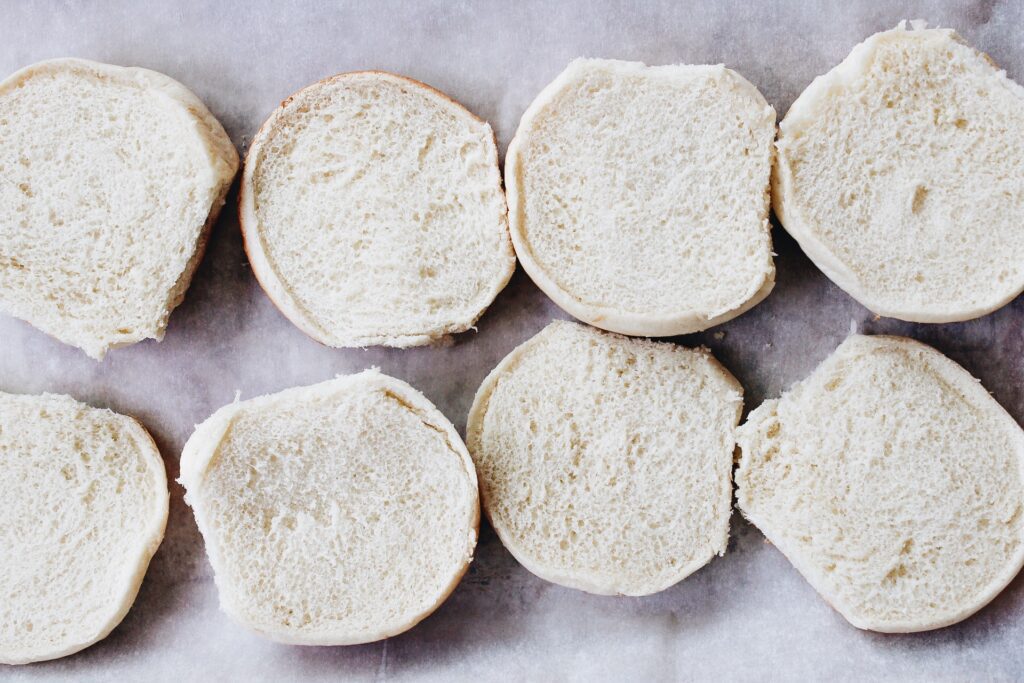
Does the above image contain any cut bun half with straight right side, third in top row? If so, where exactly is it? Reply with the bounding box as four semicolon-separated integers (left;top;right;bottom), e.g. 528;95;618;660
505;59;775;336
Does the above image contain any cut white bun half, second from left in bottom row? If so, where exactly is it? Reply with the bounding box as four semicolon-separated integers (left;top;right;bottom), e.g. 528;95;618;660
180;371;479;645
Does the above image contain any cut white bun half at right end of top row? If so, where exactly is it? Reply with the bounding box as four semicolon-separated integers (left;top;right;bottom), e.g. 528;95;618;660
773;25;1024;323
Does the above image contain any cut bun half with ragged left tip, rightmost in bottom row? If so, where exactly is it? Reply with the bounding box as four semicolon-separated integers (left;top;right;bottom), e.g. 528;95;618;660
736;335;1024;632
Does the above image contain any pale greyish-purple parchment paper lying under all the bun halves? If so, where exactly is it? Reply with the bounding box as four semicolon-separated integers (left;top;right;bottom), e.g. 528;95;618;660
0;0;1024;681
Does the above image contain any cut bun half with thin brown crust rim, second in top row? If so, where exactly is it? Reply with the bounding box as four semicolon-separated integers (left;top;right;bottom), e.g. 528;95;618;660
239;72;515;347
